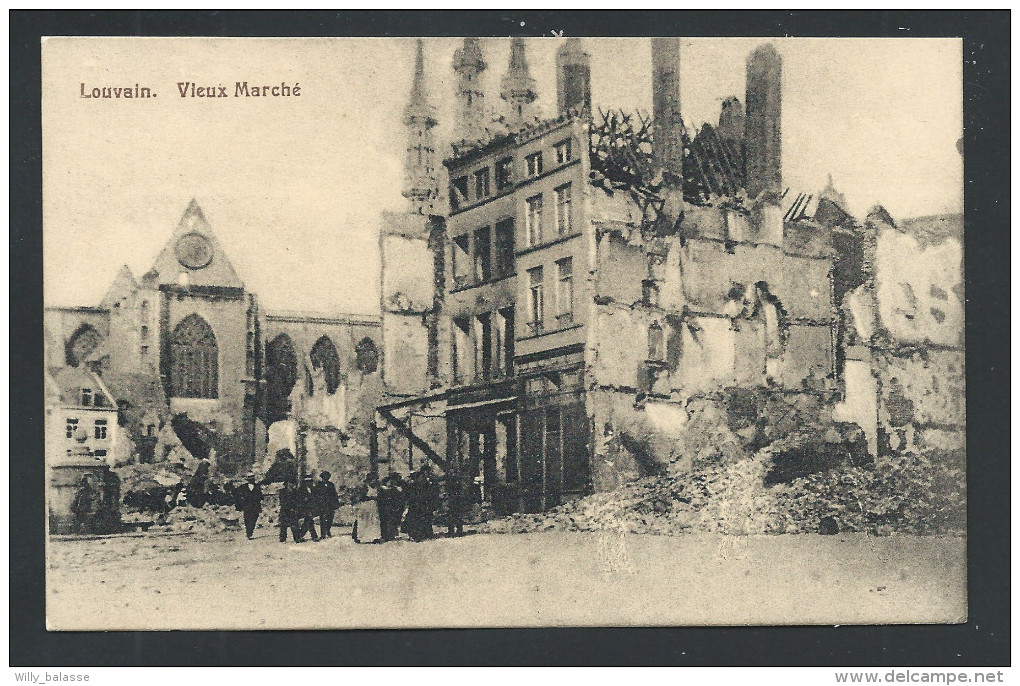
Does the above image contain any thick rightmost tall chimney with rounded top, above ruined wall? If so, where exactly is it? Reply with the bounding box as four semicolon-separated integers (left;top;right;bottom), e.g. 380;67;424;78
744;44;783;247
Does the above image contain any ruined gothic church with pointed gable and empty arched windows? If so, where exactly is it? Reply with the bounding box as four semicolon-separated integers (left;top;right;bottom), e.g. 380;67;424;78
44;199;383;487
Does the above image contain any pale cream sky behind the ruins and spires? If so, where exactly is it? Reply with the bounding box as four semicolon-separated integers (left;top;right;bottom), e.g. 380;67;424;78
43;38;963;313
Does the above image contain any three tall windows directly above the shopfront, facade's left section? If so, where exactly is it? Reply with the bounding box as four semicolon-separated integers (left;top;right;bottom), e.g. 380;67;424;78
451;307;514;383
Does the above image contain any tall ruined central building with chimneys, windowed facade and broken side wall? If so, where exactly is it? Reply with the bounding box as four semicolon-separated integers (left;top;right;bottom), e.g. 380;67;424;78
376;39;852;512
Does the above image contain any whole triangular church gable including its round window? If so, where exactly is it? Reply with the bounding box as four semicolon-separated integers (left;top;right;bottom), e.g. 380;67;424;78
143;200;244;288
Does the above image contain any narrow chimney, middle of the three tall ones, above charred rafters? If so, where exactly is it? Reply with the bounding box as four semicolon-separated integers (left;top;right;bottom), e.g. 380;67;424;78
652;38;683;187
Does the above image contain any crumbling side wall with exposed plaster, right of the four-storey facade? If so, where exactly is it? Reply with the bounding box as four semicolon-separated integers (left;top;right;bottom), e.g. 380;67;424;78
589;200;835;489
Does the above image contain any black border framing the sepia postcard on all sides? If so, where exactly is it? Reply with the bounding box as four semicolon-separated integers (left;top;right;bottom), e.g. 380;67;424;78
9;11;1011;667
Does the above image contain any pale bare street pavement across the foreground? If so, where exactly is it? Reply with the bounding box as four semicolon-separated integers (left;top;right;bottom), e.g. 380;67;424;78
47;528;966;630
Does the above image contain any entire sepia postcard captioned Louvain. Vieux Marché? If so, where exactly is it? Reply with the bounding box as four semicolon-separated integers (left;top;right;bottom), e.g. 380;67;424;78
41;36;967;631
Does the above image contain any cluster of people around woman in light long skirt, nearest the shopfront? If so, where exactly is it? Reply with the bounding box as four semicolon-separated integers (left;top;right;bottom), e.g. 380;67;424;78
351;464;440;543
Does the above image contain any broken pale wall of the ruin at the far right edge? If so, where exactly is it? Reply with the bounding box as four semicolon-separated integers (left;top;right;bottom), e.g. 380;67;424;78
836;207;966;462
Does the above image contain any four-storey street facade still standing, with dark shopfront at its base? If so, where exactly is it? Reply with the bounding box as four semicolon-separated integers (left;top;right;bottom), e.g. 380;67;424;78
441;115;593;510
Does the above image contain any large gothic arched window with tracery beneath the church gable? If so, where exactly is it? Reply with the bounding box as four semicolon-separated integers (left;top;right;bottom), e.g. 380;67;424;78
170;314;219;398
